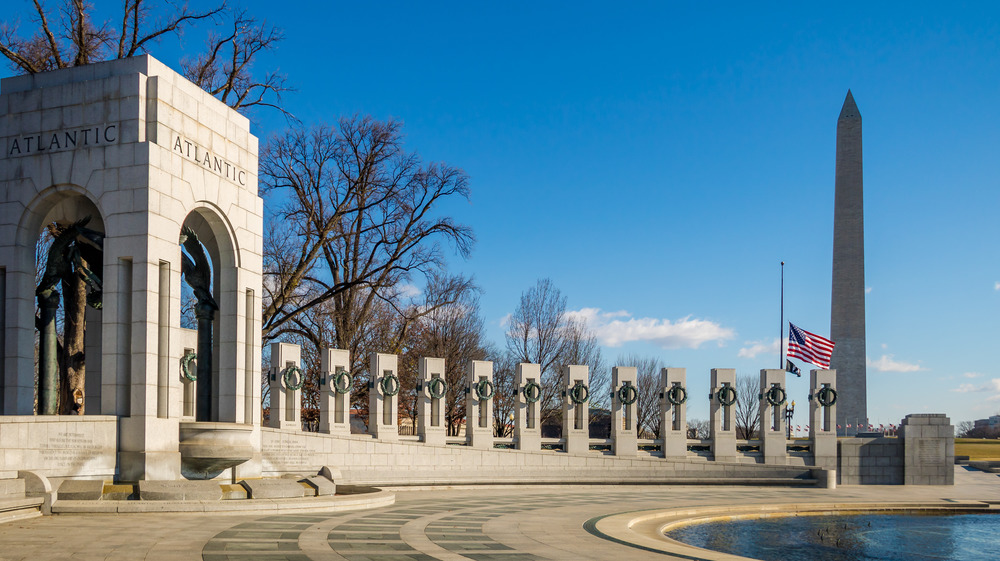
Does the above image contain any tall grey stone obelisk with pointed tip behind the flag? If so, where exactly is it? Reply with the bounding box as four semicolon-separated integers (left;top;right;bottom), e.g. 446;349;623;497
830;90;868;429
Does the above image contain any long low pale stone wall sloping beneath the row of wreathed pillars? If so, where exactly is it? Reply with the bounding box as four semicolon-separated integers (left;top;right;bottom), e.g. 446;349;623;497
262;428;813;485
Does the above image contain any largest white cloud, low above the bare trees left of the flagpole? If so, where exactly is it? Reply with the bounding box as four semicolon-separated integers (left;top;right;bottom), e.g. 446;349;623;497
566;308;736;349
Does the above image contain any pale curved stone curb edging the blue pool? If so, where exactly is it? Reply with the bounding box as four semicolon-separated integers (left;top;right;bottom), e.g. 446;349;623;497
584;501;997;561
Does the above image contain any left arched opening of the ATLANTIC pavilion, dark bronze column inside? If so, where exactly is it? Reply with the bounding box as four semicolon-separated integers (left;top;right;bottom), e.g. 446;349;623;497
21;189;105;415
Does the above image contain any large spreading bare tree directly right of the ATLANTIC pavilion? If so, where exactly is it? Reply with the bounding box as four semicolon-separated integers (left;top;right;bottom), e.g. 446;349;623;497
261;117;473;348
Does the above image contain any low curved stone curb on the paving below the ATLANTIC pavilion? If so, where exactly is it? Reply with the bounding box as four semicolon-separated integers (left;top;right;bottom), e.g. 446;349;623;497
52;490;396;514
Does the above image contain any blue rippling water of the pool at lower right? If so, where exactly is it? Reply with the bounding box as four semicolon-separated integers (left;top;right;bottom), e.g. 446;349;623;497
666;514;1000;561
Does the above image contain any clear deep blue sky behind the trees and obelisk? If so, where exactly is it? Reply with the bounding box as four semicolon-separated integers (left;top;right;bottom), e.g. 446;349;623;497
0;1;1000;424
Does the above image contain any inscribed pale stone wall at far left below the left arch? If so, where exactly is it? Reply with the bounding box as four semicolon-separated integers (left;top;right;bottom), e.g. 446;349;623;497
0;415;118;480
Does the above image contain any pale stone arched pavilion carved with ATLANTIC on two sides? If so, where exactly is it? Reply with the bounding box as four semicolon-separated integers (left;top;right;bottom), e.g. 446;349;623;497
0;56;263;480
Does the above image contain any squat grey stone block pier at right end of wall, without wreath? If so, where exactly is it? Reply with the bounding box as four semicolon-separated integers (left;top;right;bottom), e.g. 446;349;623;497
898;413;955;485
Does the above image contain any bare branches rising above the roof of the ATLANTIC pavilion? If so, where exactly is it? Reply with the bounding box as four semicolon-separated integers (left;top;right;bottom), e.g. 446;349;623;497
0;0;287;109
